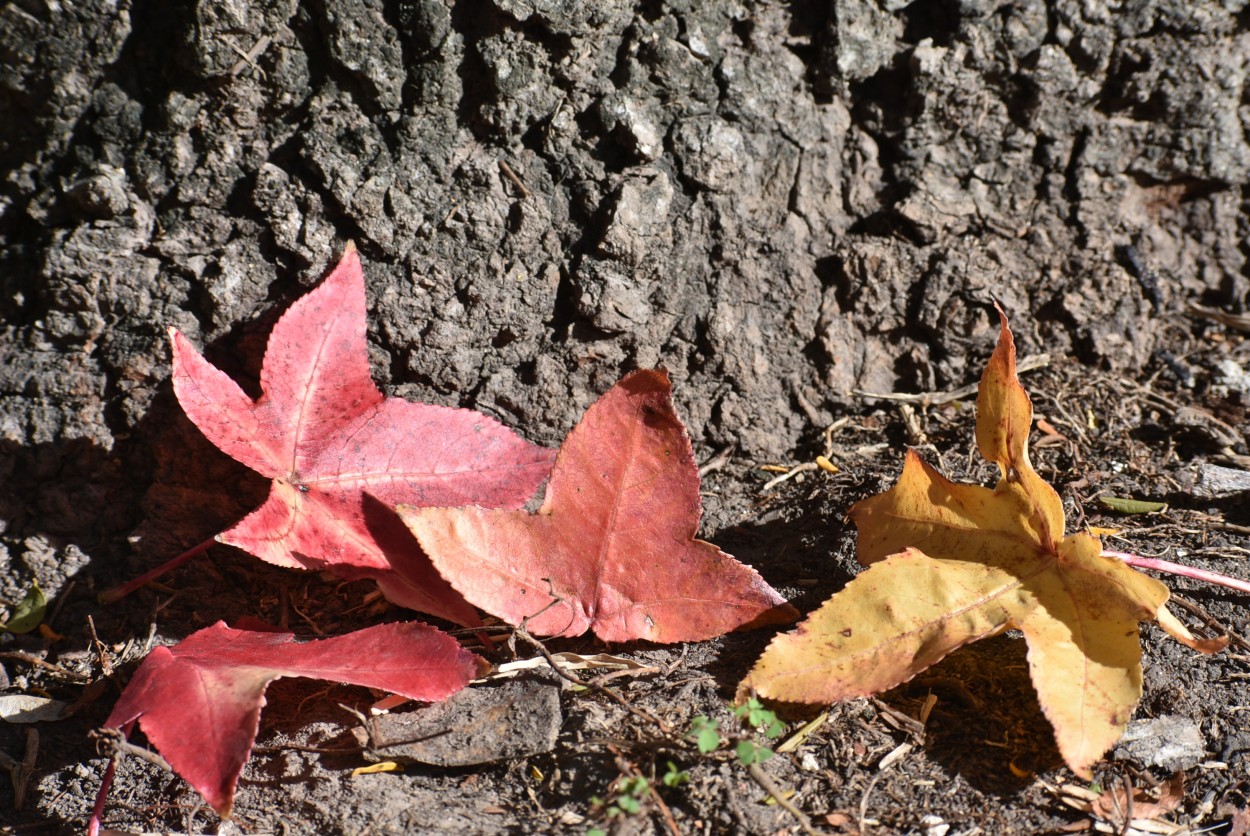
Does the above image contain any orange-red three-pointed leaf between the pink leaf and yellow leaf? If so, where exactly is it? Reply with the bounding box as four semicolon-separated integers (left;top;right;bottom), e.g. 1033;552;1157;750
398;371;798;642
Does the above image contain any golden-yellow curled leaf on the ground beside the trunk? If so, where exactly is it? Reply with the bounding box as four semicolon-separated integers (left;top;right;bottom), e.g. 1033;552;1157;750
739;311;1228;777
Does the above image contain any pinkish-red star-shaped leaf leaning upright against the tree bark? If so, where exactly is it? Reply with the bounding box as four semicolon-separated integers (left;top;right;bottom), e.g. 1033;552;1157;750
170;245;554;624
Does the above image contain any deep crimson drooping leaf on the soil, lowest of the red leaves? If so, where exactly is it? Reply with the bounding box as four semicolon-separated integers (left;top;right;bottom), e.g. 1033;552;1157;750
104;621;490;819
